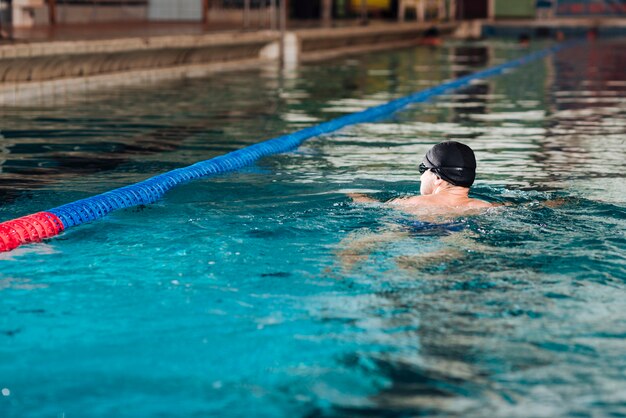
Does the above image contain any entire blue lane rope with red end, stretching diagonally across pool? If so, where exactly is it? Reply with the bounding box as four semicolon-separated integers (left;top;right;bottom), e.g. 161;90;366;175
0;42;578;252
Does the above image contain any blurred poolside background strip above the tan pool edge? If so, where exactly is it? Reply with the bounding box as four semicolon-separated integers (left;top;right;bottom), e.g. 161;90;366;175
0;0;626;38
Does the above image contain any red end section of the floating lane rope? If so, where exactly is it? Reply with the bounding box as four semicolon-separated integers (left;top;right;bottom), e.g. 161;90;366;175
0;212;65;252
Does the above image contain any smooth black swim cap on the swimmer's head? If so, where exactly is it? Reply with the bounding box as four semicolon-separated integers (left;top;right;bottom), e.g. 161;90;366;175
424;141;476;187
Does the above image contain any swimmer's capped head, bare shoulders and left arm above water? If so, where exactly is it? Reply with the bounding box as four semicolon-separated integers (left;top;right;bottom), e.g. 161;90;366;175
349;141;492;215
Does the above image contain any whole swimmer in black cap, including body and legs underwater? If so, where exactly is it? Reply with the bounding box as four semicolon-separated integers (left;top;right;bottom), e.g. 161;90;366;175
337;141;566;273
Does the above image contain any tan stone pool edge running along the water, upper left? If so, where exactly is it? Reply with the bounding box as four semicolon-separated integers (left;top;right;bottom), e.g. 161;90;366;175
0;22;456;105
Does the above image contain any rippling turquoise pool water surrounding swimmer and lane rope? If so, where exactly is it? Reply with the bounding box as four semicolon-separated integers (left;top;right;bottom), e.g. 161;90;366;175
0;40;626;417
